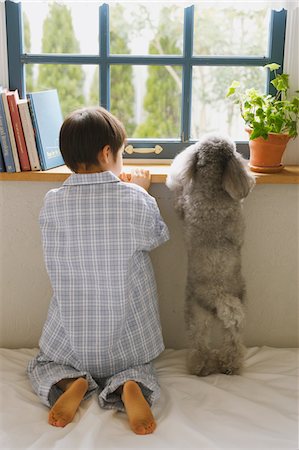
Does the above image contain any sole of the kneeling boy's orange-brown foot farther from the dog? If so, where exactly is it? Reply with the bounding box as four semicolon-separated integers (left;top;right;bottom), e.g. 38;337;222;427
48;378;88;427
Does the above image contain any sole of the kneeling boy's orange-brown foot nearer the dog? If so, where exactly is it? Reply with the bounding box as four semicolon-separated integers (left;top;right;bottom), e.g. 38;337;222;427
122;381;156;434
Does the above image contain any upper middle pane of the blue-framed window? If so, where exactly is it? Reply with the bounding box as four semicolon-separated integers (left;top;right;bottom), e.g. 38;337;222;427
110;2;184;55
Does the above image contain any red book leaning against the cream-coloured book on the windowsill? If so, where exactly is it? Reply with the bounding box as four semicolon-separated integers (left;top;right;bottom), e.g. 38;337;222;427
6;90;31;171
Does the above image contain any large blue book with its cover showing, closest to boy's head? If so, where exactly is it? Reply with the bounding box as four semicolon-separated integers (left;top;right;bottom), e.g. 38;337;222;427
27;89;64;170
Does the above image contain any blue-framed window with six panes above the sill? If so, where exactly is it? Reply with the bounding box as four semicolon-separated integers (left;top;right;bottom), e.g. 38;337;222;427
6;0;286;160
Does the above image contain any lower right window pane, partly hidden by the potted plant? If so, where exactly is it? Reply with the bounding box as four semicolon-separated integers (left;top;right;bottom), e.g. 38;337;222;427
191;67;267;141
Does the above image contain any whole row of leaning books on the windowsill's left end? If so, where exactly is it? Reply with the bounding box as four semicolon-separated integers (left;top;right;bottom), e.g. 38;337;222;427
0;87;64;172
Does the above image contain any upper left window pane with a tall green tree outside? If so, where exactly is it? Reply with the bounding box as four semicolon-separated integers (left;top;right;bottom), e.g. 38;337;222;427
22;1;99;55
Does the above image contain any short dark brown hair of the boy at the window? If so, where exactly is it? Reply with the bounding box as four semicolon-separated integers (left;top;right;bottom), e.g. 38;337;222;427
59;107;126;172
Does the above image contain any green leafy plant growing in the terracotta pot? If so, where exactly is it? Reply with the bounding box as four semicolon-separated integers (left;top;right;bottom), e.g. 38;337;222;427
226;63;299;140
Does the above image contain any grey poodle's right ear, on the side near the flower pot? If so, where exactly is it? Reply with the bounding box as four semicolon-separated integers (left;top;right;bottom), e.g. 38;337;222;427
222;153;255;200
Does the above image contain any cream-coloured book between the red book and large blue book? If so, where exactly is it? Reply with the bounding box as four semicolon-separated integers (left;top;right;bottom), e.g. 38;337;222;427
17;99;41;170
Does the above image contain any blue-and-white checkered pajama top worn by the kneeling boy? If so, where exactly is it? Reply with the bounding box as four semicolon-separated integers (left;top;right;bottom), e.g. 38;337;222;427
40;172;169;377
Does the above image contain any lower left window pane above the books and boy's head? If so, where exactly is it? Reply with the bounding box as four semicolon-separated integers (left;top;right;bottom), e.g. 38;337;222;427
25;64;99;117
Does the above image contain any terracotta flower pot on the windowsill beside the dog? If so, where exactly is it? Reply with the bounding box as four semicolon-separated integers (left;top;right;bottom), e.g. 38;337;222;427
246;128;290;173
